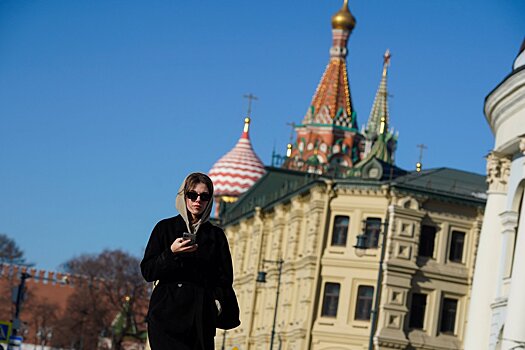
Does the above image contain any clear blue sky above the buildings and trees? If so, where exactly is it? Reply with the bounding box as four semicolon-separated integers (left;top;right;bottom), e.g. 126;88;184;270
0;0;525;269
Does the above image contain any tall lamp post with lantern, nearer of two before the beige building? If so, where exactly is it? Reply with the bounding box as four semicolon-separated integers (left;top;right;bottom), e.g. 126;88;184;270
354;221;388;350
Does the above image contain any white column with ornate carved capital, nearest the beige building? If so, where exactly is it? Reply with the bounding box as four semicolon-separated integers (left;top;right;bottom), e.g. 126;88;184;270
465;153;508;350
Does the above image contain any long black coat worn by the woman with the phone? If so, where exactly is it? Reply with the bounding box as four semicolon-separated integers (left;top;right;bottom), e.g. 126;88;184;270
140;215;233;347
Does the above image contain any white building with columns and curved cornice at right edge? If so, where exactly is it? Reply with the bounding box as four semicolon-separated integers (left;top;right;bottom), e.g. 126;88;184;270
465;41;525;350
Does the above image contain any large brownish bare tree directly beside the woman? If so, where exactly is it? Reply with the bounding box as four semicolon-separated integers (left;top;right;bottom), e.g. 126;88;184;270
62;250;148;350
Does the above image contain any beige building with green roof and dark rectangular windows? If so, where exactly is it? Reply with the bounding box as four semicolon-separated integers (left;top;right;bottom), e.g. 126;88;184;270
216;167;486;350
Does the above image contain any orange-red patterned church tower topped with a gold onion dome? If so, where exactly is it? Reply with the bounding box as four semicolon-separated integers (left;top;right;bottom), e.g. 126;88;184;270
283;0;361;174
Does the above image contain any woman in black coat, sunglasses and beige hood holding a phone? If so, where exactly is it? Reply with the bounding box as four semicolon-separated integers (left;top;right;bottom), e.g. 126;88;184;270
140;173;238;350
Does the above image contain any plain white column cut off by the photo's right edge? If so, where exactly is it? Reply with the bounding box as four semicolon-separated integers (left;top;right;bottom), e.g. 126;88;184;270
502;196;525;350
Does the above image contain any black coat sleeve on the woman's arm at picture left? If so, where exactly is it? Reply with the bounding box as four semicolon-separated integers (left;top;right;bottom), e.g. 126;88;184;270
140;222;180;282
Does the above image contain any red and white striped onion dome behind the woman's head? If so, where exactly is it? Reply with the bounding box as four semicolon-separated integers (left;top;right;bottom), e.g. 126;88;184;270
209;118;266;197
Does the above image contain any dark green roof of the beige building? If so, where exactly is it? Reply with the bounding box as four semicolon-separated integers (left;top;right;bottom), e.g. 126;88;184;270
220;165;487;225
